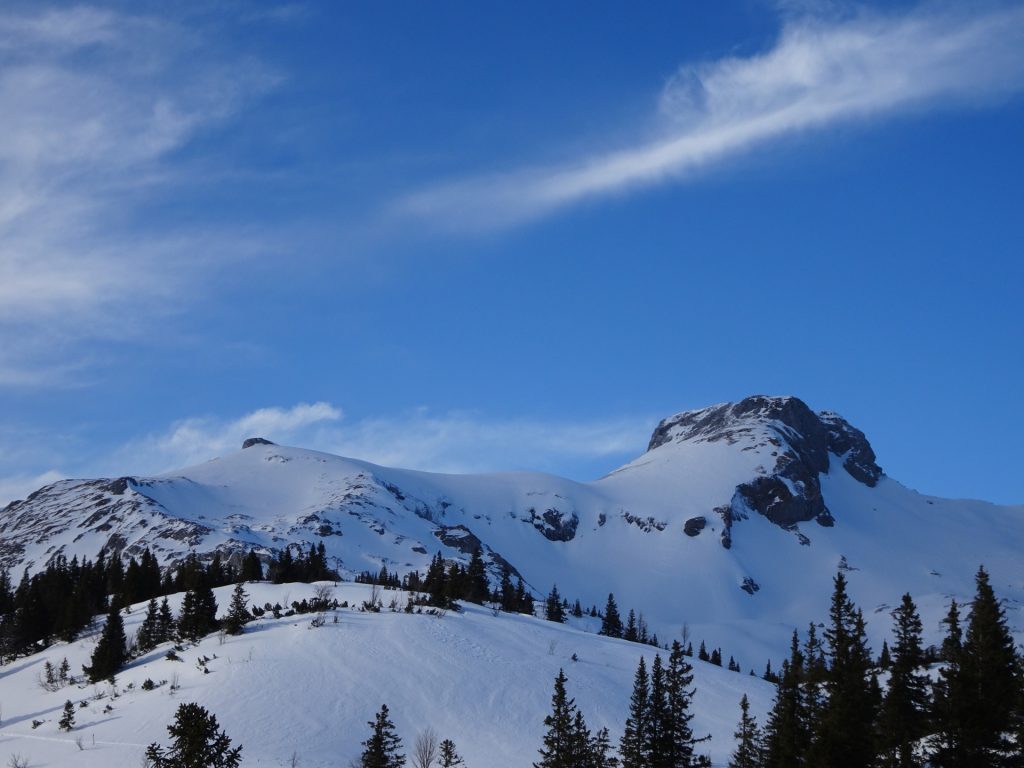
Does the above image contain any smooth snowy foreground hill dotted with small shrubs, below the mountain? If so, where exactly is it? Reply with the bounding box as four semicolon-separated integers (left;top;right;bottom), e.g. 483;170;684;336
0;583;774;768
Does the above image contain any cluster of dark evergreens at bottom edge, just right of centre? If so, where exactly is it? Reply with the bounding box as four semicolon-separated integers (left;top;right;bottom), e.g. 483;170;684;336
534;642;711;768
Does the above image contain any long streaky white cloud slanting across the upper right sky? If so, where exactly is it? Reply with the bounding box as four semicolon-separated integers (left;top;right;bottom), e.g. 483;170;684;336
395;4;1024;231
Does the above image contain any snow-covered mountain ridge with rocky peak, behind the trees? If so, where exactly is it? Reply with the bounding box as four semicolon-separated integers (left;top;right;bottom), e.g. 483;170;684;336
0;396;1024;669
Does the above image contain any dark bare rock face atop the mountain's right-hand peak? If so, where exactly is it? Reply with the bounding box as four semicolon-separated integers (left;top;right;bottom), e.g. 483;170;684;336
647;395;883;547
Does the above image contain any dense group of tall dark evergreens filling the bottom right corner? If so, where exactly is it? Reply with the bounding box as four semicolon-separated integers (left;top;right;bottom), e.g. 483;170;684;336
730;568;1024;768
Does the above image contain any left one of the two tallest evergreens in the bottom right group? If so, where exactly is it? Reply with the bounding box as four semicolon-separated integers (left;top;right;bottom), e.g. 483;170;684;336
809;572;877;768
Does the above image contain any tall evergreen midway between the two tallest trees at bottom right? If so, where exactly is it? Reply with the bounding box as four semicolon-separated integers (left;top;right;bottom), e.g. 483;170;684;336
879;594;929;768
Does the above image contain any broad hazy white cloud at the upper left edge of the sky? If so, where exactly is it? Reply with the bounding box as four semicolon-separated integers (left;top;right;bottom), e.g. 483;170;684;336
0;6;276;386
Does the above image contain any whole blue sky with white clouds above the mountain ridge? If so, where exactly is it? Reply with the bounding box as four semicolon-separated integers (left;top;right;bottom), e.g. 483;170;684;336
0;0;1024;503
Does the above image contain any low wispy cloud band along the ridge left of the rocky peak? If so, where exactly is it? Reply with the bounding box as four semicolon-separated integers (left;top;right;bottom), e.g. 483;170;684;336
0;402;651;506
